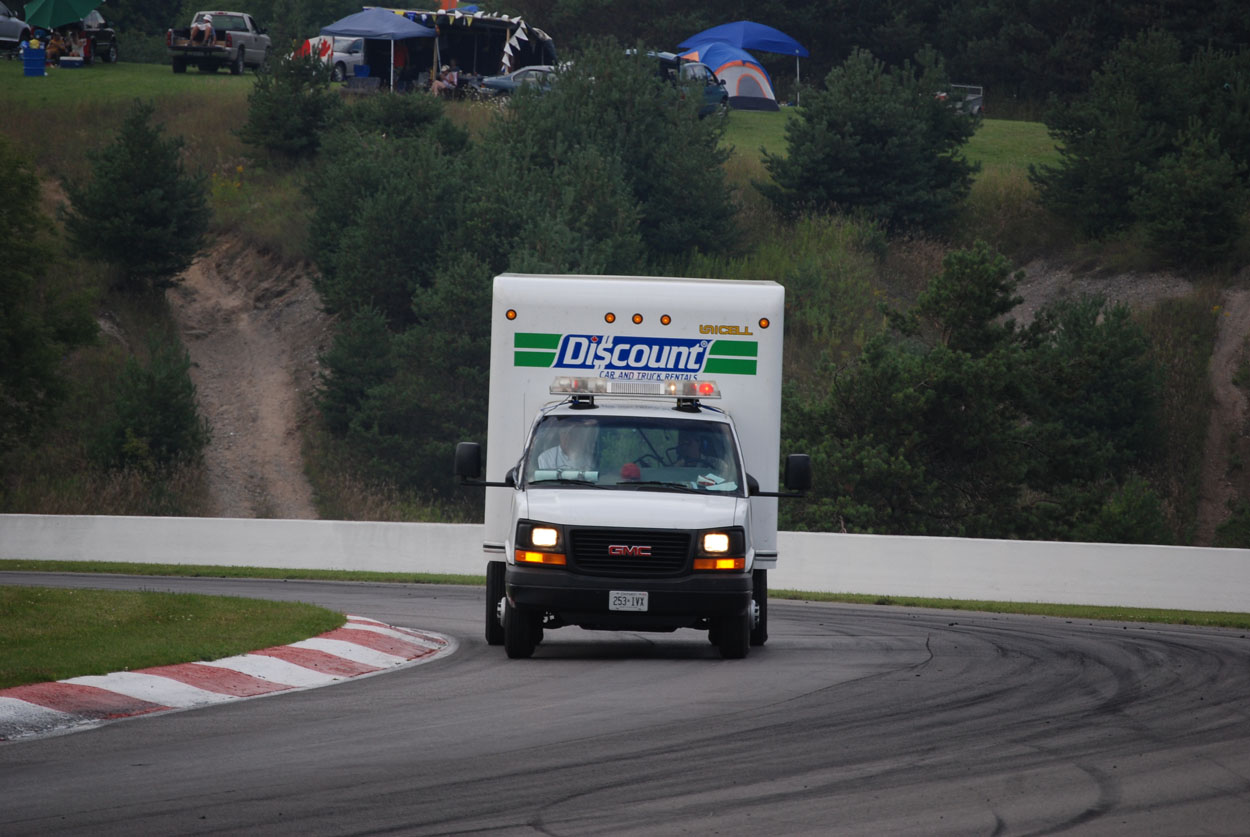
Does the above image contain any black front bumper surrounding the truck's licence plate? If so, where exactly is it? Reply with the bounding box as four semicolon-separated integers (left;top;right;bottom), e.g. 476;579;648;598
505;565;751;631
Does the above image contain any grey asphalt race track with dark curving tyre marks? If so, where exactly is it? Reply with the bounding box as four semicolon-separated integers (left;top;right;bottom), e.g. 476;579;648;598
0;573;1250;836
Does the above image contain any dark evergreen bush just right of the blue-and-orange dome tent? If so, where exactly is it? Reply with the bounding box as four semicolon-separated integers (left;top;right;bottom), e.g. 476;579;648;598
759;50;976;230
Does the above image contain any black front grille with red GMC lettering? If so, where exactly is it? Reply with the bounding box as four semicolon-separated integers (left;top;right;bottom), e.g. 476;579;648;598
569;528;690;578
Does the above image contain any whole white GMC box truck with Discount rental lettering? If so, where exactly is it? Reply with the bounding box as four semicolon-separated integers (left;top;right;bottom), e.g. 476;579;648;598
455;274;811;658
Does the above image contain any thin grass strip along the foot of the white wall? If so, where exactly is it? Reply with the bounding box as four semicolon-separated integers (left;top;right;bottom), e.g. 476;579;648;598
0;560;1250;630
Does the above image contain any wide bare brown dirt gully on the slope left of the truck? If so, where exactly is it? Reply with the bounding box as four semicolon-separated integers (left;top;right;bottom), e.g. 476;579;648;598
169;237;331;520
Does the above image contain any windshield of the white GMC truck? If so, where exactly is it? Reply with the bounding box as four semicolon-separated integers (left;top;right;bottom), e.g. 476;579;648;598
525;416;745;496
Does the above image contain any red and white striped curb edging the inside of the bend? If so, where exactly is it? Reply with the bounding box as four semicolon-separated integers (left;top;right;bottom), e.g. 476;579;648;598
0;616;455;741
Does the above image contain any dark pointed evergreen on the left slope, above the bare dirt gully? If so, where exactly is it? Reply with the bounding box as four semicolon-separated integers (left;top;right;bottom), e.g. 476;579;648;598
63;101;210;292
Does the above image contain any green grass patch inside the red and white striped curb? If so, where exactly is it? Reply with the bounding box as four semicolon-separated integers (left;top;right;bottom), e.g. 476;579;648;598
0;587;344;688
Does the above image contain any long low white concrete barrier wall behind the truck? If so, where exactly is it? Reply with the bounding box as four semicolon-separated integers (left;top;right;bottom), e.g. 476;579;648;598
0;515;1250;612
